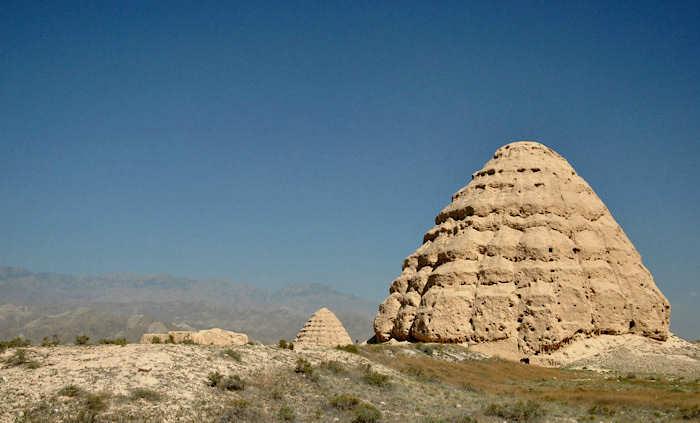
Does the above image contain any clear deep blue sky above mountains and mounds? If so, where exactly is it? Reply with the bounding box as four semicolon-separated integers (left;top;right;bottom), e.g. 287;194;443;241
0;1;700;338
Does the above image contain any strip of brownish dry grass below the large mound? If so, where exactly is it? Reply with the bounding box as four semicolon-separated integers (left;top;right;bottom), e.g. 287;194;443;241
362;347;700;409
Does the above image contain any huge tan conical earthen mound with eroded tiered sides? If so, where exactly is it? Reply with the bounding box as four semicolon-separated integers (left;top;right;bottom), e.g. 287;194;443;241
374;142;670;354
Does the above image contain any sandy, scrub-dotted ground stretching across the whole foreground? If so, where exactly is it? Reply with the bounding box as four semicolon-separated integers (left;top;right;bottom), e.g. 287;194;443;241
0;342;700;423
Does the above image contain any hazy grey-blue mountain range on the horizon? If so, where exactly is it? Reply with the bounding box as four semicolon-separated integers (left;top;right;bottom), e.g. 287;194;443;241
0;267;377;343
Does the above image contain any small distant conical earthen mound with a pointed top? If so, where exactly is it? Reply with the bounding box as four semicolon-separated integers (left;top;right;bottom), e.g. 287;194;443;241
294;307;352;348
